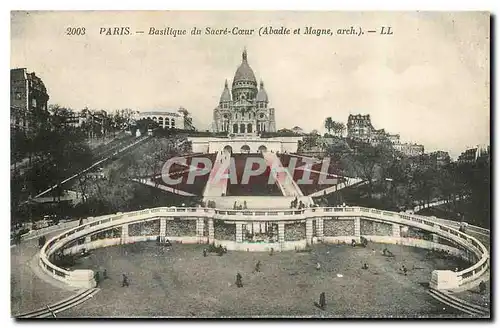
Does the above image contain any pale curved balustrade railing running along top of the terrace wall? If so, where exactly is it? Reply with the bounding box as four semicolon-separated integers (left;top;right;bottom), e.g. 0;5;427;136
39;207;489;287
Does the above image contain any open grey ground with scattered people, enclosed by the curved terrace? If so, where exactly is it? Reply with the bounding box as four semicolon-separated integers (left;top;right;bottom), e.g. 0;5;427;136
60;242;465;317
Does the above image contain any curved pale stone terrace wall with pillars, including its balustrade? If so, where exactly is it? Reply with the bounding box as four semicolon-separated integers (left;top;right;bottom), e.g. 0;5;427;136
39;207;489;289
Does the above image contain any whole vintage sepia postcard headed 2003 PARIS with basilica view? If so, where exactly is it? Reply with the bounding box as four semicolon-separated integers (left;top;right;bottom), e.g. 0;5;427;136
10;11;491;319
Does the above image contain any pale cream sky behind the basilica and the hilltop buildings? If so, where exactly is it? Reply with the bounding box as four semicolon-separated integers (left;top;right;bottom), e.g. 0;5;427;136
11;11;490;157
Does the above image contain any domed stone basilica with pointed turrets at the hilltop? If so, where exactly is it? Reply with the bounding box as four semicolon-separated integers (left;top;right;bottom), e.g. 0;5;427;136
212;50;276;136
